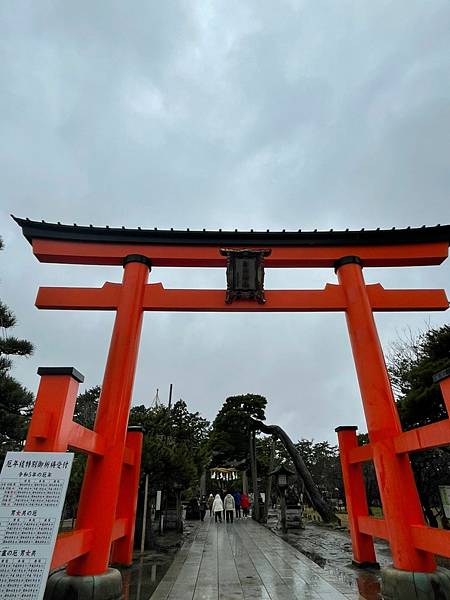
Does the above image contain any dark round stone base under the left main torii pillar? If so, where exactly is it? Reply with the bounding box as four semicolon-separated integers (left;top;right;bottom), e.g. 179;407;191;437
44;569;122;600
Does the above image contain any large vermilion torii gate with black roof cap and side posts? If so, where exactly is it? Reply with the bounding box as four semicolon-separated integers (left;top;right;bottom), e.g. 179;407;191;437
15;218;450;596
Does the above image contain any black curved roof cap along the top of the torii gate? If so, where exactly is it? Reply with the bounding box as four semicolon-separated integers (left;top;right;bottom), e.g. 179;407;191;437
11;215;450;247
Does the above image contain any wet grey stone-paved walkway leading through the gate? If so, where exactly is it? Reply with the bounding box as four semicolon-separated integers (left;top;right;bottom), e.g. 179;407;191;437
151;517;359;600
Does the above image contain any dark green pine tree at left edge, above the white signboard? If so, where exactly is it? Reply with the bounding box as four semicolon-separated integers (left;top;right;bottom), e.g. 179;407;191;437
0;238;33;463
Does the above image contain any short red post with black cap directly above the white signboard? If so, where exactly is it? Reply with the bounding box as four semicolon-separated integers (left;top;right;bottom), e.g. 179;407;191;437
24;367;84;452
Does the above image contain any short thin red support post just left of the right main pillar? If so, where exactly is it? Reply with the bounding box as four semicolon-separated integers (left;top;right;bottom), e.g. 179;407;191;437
335;425;377;566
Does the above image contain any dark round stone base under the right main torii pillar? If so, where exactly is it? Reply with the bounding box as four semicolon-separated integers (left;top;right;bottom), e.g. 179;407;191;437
381;567;450;600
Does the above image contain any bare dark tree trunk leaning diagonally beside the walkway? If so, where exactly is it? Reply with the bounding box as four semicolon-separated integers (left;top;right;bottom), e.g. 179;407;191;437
251;419;339;523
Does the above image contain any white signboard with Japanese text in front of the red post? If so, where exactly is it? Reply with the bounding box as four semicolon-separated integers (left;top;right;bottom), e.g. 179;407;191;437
0;452;73;600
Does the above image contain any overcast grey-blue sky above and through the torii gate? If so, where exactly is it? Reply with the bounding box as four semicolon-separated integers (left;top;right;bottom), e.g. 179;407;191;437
0;0;450;441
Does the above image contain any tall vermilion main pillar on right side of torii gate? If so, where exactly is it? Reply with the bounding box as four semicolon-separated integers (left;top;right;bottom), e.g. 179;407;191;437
335;256;436;572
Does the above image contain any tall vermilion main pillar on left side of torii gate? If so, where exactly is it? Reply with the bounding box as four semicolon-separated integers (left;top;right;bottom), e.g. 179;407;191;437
67;255;150;575
